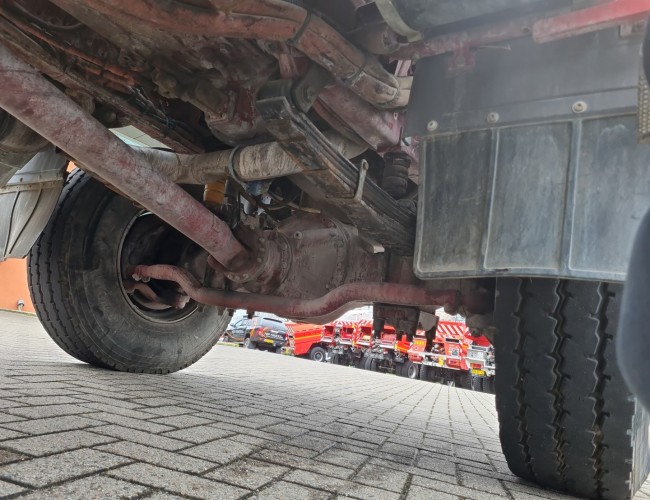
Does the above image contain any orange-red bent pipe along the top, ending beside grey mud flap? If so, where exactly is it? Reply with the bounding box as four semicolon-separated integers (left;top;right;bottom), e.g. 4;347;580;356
69;0;404;108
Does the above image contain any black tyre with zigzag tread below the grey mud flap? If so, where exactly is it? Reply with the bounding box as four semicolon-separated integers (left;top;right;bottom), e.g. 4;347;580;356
495;279;648;499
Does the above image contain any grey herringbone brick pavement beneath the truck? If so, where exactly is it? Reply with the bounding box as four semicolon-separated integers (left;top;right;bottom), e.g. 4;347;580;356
0;312;650;500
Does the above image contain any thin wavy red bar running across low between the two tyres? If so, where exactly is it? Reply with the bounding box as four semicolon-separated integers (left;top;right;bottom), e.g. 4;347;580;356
133;265;459;319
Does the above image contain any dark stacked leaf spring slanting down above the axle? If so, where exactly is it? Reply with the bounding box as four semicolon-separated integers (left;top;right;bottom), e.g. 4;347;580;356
257;82;415;255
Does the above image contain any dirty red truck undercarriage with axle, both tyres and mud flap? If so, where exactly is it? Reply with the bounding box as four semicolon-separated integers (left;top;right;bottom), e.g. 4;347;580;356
0;0;650;498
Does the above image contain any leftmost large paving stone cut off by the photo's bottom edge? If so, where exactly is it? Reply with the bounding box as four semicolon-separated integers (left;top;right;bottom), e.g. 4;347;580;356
16;476;150;500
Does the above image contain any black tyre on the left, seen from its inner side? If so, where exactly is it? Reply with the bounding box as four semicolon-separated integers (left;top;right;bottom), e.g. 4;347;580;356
28;170;229;373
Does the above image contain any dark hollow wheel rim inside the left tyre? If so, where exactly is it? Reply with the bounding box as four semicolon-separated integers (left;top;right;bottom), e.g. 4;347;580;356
117;211;199;323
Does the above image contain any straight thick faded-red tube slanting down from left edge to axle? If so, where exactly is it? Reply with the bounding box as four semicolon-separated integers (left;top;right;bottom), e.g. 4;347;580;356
0;45;248;270
